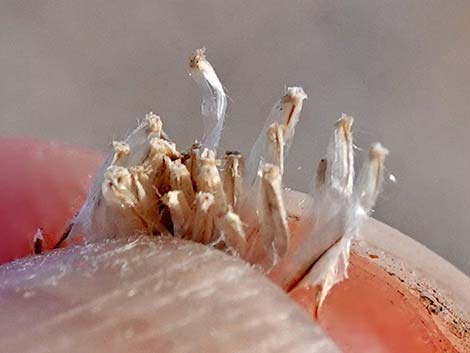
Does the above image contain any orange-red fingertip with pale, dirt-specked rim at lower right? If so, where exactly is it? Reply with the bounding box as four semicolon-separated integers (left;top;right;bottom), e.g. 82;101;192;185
290;220;470;353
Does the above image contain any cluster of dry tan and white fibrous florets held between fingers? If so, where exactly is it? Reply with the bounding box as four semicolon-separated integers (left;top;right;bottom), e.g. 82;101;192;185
66;49;387;305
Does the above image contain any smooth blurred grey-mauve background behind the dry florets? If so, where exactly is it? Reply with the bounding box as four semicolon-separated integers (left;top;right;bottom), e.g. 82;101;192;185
0;0;470;274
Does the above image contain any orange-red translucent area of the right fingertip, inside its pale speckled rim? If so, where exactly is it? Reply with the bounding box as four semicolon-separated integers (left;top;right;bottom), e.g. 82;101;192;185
290;254;459;353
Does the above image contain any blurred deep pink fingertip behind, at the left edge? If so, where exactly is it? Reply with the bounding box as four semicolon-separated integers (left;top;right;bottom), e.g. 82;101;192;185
0;138;102;264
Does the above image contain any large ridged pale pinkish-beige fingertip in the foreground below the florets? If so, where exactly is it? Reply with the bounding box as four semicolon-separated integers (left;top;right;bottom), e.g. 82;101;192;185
0;237;337;353
